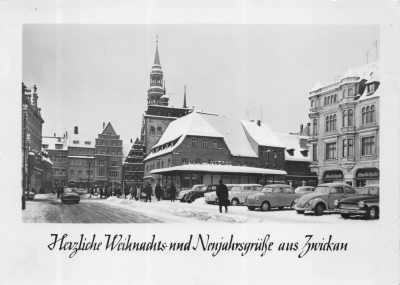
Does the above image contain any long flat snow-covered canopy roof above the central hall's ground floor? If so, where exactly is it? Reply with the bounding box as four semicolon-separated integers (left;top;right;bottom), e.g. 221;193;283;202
150;164;287;175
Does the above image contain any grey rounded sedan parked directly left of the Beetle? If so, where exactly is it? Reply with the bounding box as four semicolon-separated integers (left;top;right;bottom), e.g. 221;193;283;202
245;184;301;211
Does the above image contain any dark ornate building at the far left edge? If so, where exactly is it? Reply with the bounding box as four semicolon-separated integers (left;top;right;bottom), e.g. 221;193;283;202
21;83;53;193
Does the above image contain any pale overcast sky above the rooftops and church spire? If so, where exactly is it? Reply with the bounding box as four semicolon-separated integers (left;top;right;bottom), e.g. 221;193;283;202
22;25;379;139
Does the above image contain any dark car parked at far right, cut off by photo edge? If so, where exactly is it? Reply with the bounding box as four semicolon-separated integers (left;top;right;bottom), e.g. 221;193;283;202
334;184;379;219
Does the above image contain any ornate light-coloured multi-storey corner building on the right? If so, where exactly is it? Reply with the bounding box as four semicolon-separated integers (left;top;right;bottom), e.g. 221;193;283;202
309;61;380;187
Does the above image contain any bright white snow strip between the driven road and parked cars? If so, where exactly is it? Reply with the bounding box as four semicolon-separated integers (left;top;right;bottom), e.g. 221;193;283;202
105;197;376;223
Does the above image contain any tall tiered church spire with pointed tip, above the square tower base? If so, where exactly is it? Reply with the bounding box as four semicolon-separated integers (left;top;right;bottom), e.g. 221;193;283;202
147;35;169;106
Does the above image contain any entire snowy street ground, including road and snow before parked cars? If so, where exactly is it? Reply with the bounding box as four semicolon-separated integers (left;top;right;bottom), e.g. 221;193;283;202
23;194;376;223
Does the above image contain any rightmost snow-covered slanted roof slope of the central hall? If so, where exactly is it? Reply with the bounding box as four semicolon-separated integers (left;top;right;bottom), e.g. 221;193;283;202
241;121;284;148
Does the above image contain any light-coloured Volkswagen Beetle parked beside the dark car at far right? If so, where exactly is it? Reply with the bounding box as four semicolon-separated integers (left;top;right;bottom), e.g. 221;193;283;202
293;183;357;216
